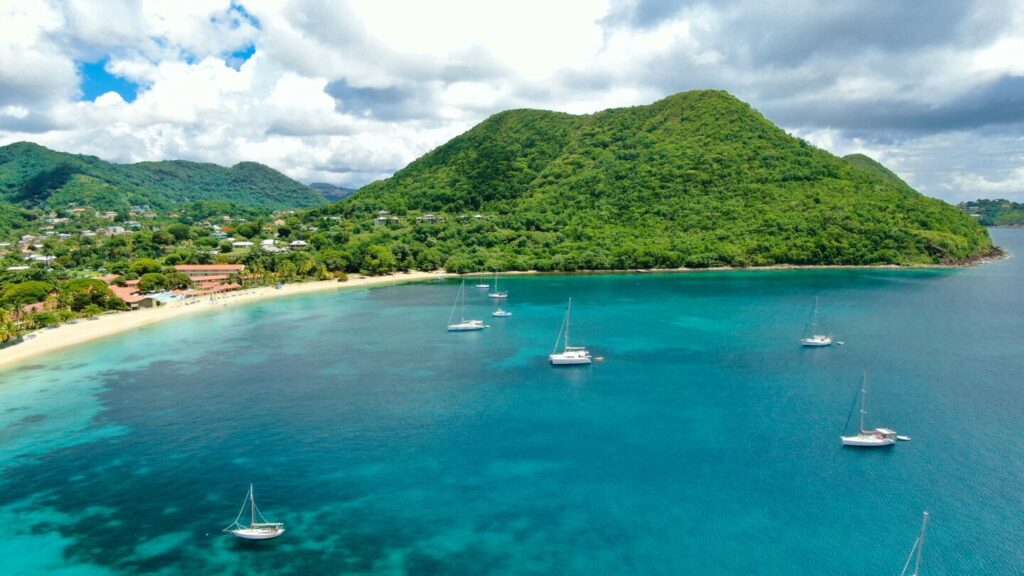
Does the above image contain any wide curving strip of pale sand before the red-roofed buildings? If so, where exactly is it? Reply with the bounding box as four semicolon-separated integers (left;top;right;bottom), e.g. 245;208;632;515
0;272;446;370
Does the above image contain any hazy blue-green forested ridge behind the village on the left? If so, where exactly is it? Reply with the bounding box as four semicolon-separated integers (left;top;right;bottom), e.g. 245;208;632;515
0;142;325;210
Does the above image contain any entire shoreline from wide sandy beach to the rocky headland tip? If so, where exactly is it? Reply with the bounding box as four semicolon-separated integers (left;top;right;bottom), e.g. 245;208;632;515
0;250;1012;372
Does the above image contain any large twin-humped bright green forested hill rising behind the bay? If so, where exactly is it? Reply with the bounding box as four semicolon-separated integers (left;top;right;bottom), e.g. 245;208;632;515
315;91;992;270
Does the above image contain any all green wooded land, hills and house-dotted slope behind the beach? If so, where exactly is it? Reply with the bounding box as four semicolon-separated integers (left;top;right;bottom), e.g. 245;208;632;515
0;91;993;340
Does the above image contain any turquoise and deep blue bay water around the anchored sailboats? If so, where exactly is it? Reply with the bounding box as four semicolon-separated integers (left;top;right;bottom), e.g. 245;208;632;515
0;226;1024;576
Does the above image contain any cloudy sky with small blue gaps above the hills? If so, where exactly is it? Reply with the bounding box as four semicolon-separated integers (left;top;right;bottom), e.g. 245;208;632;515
0;0;1024;201
